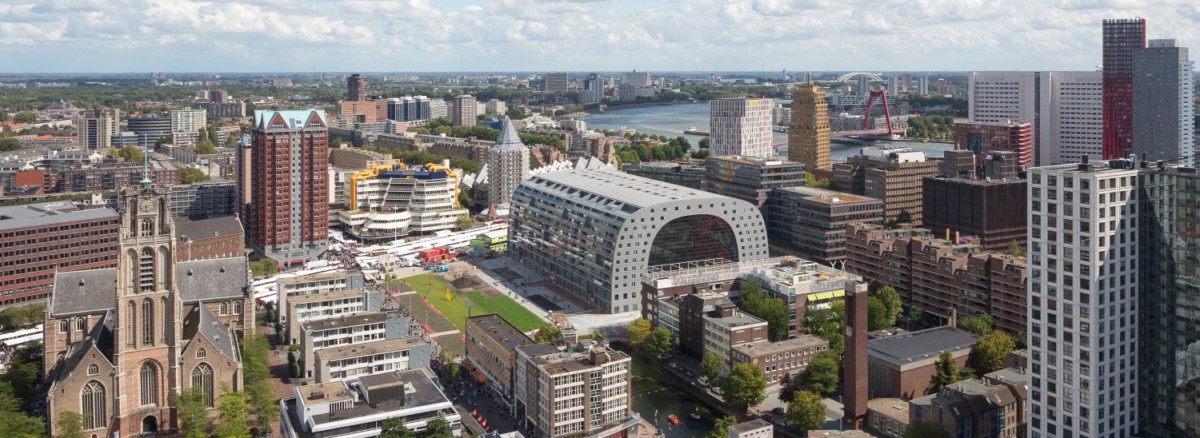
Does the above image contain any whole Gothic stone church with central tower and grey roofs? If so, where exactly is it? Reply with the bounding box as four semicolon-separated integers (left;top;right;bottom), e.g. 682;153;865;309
44;181;254;438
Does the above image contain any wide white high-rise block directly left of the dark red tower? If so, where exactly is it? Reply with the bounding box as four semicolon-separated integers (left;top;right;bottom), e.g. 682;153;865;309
967;72;1104;166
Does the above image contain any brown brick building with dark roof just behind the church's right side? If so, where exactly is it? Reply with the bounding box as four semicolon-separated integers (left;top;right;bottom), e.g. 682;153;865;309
175;216;246;262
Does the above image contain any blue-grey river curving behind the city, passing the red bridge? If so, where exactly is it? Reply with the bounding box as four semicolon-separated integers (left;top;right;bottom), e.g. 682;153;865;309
587;102;954;161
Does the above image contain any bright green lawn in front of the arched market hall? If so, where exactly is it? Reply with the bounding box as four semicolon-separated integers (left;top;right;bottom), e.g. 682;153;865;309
403;274;544;331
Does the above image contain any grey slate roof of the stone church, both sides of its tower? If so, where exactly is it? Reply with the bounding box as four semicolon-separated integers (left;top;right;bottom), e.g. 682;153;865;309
50;257;250;316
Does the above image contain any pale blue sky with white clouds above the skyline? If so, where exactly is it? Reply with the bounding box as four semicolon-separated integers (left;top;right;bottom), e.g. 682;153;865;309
0;0;1200;73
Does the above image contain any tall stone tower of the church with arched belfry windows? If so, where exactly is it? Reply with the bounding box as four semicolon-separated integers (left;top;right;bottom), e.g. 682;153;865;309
113;180;182;436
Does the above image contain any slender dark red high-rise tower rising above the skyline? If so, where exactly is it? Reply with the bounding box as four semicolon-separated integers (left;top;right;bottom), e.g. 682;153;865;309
1104;18;1146;160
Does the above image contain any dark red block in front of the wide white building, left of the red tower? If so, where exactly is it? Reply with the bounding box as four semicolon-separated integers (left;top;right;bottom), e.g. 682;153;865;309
954;120;1033;168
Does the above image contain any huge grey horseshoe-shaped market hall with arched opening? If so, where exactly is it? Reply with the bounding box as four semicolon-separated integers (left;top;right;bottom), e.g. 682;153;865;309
509;165;768;313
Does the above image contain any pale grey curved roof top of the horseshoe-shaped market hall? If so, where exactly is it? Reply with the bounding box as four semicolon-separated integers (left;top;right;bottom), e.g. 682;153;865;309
523;168;742;208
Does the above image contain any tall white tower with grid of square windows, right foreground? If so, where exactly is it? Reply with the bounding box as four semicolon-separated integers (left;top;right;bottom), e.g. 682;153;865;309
1027;161;1140;438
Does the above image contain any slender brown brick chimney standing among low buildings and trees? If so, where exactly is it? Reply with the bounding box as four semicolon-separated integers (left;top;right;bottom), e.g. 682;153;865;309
841;279;868;430
